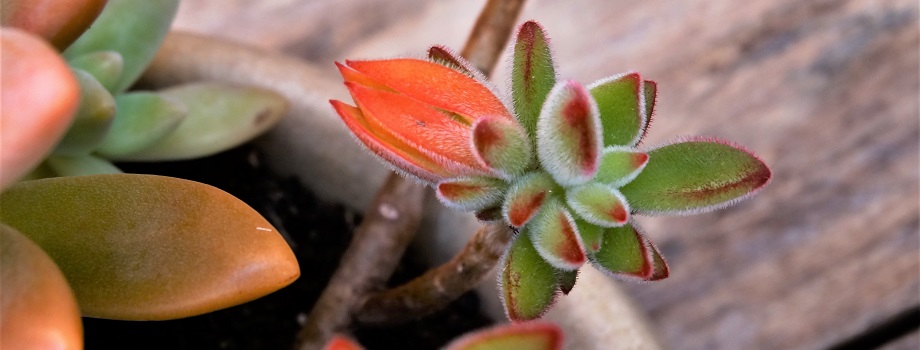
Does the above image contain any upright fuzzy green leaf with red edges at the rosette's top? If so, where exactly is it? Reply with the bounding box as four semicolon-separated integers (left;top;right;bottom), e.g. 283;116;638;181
511;21;556;141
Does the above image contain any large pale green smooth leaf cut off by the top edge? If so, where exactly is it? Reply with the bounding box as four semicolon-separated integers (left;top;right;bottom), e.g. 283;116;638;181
64;0;179;93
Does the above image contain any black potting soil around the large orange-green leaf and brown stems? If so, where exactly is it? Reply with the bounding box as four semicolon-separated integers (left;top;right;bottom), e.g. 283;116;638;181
83;145;491;350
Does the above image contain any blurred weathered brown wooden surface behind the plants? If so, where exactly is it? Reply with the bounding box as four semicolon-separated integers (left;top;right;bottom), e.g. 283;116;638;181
169;0;920;349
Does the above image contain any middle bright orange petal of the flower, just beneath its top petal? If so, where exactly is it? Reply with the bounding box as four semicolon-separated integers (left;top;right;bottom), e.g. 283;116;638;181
345;80;489;175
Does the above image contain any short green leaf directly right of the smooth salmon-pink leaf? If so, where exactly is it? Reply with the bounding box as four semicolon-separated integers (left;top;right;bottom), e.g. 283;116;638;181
53;69;115;156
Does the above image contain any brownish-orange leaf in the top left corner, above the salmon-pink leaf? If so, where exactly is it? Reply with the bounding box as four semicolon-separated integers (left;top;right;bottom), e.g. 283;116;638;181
0;0;106;50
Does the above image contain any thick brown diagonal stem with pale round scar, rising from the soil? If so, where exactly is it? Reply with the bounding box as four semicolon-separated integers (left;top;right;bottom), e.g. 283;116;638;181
296;174;427;349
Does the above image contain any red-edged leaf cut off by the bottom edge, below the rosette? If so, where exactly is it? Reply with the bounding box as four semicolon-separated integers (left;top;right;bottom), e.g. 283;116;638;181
445;322;562;350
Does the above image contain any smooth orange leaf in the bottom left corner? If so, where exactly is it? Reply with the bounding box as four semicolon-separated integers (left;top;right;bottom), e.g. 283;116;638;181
0;224;83;349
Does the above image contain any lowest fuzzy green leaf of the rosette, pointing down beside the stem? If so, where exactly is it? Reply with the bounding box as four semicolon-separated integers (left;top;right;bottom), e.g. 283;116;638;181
498;232;558;321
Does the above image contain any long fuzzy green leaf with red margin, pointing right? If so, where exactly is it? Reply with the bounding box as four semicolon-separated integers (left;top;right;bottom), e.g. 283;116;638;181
620;138;772;214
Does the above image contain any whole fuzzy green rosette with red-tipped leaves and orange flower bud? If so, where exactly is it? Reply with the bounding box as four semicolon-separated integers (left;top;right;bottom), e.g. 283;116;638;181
331;21;772;320
